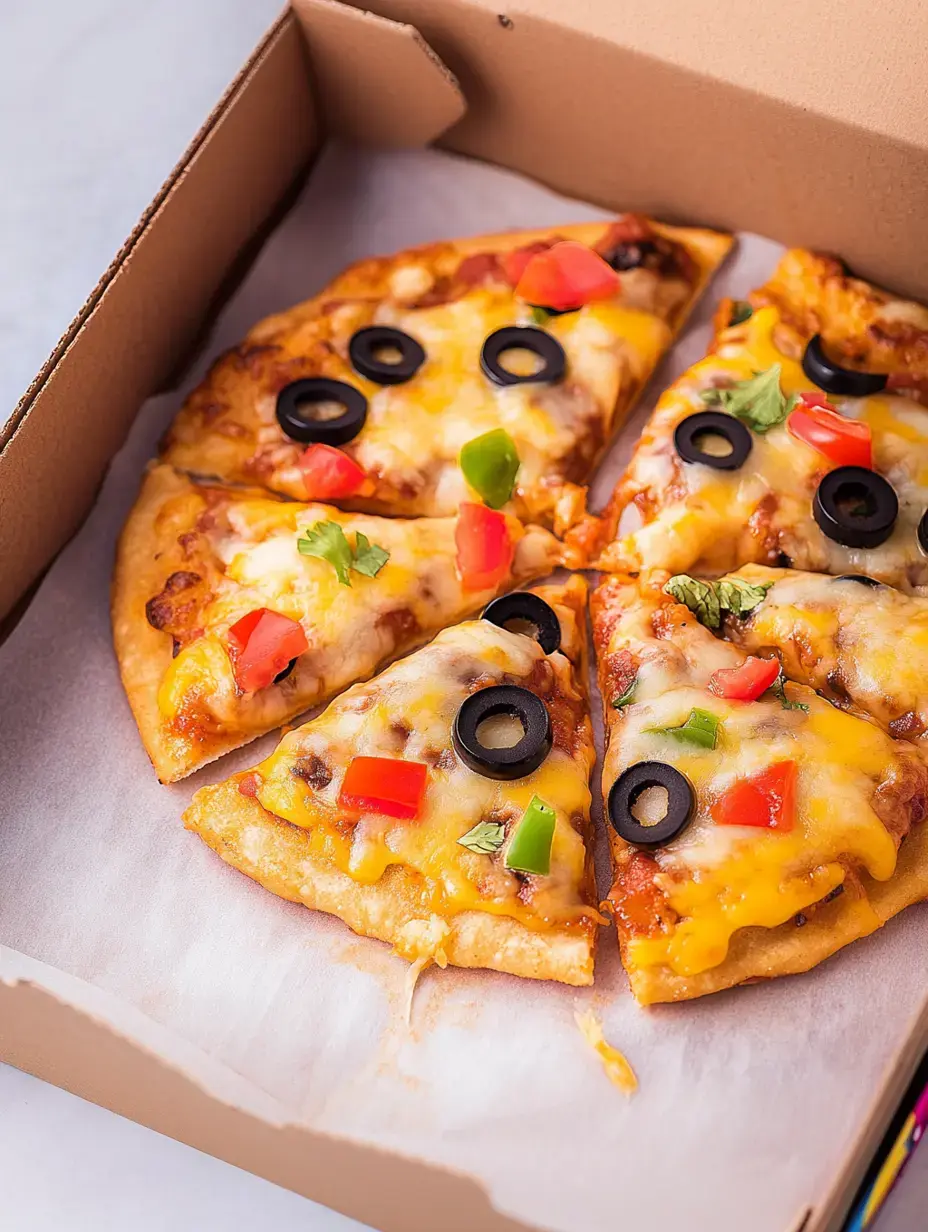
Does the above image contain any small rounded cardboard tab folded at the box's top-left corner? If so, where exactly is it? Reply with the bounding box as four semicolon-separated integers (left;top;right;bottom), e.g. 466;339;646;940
293;0;467;147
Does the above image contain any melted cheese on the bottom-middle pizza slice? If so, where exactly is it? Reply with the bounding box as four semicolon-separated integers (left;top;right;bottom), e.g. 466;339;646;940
250;621;593;929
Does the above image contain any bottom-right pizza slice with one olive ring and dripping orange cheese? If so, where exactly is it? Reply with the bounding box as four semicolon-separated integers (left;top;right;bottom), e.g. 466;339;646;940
592;578;928;1004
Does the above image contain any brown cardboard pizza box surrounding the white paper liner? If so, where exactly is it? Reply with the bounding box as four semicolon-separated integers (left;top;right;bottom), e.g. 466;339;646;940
0;0;928;1232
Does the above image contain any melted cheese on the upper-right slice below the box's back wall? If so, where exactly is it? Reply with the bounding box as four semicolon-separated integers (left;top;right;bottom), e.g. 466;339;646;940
606;306;928;588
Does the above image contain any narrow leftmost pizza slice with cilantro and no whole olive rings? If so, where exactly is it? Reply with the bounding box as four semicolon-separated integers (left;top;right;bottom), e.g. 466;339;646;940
112;466;561;782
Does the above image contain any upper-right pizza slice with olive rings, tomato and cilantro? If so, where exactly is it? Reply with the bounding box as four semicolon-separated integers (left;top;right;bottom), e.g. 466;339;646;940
599;250;928;591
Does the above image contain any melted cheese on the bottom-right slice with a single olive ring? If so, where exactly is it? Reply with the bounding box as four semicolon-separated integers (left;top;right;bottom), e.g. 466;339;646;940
609;588;900;976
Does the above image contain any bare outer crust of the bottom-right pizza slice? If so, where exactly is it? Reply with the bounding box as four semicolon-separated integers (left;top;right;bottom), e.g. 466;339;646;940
622;824;928;1005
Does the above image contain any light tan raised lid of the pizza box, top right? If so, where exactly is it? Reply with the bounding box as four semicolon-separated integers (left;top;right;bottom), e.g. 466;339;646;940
386;0;928;149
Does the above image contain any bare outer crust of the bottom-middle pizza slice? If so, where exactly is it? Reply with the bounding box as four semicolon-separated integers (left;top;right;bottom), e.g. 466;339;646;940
184;780;598;986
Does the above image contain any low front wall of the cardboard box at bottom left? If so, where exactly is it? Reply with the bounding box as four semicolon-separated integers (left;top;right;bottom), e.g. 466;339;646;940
0;947;532;1232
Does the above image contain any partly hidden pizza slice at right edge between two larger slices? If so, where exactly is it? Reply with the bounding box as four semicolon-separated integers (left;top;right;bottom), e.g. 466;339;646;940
709;564;928;748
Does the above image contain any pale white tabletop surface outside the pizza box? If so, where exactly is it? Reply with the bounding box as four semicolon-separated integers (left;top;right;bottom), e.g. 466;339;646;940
0;0;928;1232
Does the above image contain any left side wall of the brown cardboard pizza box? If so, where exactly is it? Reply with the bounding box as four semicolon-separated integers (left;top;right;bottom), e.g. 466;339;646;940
0;12;318;620
